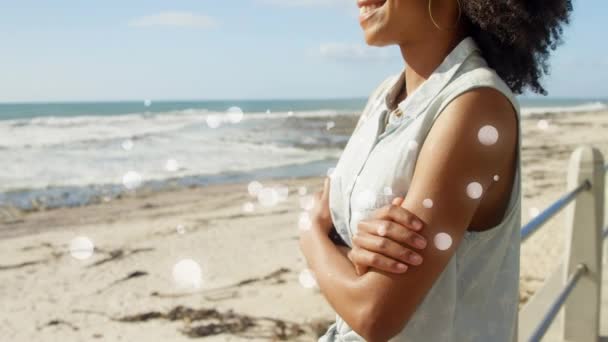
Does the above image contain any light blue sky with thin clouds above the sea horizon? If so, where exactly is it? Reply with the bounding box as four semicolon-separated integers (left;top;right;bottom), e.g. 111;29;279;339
0;0;608;102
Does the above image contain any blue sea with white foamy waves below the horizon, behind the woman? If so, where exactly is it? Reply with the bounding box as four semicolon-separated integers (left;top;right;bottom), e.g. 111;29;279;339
0;98;608;210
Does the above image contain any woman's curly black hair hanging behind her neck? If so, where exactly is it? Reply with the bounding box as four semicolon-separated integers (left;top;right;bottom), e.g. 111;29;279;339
460;0;572;95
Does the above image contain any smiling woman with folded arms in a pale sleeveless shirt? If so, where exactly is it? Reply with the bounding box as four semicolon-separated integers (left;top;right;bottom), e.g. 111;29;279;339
300;0;572;342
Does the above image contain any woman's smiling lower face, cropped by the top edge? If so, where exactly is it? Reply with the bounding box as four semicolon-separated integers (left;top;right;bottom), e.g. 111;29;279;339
357;0;438;46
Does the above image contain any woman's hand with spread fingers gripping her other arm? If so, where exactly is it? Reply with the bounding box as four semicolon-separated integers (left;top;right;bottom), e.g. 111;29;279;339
348;197;427;275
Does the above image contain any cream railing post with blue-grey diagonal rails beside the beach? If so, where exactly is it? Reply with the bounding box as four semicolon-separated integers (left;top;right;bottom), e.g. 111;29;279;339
518;146;608;342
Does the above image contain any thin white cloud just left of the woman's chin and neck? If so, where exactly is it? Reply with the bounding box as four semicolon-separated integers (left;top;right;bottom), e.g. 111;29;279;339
318;43;396;61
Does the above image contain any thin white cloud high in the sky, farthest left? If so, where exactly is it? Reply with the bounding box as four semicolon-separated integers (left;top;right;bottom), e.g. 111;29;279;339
129;11;217;28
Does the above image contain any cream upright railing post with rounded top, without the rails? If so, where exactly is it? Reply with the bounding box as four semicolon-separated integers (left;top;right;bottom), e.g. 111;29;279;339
562;146;604;342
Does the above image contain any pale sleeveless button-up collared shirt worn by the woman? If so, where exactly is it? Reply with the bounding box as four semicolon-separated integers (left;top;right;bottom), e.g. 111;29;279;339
318;37;521;342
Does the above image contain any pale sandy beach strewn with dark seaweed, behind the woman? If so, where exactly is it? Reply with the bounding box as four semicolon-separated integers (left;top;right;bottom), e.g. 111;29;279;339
0;111;608;341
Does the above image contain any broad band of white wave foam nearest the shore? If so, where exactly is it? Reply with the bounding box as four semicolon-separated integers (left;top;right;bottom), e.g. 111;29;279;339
0;141;340;193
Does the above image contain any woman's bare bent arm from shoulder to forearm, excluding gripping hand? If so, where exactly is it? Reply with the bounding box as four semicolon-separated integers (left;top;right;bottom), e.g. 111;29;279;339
301;88;517;342
